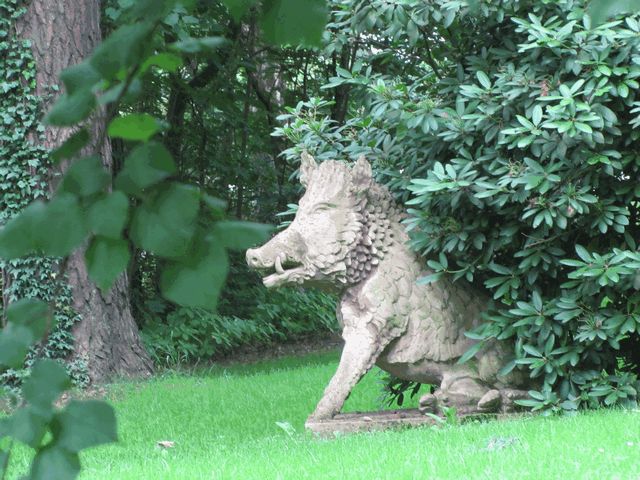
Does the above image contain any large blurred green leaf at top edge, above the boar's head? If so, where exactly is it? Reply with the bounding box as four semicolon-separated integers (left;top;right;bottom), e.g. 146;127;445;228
260;0;329;46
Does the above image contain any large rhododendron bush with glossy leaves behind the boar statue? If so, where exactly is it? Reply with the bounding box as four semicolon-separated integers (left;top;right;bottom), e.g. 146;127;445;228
274;0;640;411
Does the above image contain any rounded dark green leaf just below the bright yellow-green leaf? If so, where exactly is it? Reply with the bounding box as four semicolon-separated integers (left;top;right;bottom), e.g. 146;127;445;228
116;142;177;194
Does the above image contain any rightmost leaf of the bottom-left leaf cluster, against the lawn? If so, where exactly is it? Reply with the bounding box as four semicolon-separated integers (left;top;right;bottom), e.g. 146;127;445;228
53;400;118;452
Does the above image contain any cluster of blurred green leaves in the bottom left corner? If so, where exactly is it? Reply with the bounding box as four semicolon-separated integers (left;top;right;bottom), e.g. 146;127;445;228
0;310;117;480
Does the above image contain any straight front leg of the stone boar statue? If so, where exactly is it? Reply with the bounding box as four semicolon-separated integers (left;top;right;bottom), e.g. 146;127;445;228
309;331;388;420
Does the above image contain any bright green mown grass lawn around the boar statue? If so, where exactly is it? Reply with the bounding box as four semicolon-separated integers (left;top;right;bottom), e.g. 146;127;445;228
3;353;640;480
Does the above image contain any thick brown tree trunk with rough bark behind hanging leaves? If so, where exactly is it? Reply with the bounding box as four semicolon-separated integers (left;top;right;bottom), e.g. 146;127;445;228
17;0;152;382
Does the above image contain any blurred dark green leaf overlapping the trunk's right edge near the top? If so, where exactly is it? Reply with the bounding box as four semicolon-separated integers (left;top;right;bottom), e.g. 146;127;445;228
89;22;153;80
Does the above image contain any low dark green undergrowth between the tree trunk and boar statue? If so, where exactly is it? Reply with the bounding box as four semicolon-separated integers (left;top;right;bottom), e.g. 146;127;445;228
141;287;337;367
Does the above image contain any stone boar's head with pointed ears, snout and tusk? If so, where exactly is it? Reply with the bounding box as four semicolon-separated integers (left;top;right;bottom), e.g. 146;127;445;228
247;153;380;289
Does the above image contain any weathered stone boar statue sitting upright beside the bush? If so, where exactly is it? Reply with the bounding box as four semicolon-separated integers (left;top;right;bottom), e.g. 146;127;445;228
246;153;526;425
